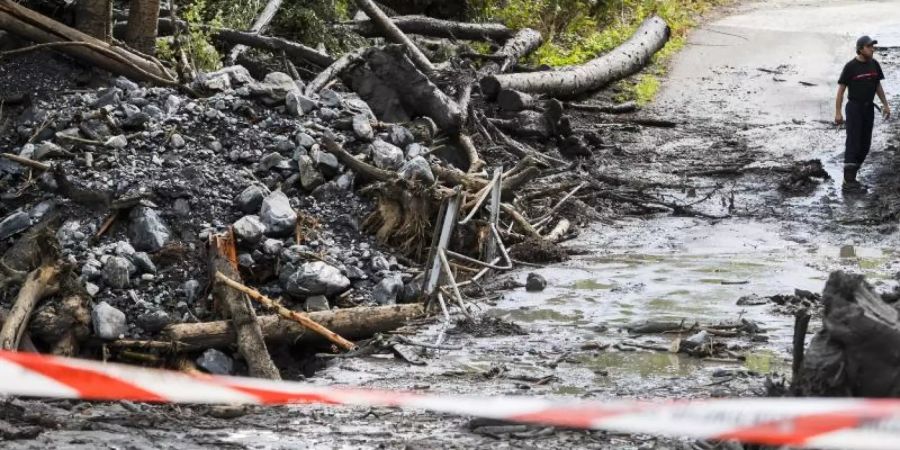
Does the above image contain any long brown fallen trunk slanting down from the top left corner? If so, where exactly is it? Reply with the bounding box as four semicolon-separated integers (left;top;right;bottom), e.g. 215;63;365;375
0;0;178;85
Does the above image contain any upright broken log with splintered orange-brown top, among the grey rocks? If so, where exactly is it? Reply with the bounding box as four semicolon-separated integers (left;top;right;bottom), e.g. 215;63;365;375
208;228;281;380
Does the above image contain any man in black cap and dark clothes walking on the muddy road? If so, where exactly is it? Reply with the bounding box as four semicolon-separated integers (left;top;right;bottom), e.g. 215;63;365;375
834;36;891;191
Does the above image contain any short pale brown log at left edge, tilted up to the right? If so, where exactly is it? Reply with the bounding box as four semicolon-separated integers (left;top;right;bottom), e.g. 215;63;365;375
0;264;60;350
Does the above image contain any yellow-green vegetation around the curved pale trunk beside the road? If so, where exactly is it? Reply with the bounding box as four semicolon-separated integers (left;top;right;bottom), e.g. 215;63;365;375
470;0;728;103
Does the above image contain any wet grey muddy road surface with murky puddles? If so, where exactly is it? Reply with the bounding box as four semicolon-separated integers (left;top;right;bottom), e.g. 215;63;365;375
0;1;900;449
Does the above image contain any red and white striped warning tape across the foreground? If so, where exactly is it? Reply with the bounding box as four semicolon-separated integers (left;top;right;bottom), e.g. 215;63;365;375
0;351;900;449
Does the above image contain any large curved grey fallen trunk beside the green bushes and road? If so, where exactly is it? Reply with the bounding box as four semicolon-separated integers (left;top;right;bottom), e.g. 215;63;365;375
480;16;669;98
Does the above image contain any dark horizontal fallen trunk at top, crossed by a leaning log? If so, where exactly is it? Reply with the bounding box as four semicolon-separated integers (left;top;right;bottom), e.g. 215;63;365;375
345;16;515;42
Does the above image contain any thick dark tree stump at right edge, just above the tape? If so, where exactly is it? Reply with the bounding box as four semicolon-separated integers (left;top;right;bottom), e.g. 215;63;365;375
791;271;900;397
